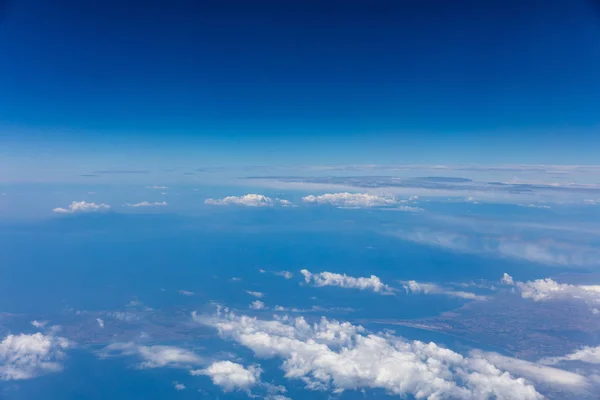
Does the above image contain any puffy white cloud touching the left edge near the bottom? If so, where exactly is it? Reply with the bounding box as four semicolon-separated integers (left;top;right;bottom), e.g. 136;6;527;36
0;333;69;381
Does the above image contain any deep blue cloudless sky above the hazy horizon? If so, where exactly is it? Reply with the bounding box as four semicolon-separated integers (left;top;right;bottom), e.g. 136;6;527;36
0;0;600;167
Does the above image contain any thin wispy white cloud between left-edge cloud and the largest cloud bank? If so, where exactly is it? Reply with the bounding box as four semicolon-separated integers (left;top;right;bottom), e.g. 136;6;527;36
99;342;202;368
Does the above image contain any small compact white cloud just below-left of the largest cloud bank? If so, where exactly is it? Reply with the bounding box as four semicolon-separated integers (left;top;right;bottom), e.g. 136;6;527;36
191;361;262;392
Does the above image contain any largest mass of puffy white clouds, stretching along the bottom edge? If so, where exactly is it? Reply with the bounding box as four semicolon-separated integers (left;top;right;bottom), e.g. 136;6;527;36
194;309;543;400
